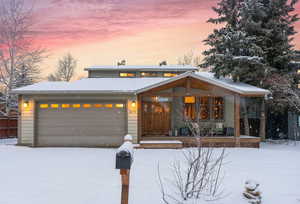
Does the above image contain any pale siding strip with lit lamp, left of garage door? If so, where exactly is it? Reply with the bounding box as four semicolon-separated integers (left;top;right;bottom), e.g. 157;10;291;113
19;99;35;145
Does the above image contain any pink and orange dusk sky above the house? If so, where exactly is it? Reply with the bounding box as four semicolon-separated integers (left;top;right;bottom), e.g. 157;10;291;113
28;0;300;75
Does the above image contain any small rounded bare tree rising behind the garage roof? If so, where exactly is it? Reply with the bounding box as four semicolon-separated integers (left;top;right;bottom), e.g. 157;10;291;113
48;53;77;81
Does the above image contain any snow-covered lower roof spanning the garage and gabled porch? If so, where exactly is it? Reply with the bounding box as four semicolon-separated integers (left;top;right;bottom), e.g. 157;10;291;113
13;72;270;95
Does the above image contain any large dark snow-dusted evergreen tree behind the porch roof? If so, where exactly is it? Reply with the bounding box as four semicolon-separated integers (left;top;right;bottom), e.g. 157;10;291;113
201;0;298;87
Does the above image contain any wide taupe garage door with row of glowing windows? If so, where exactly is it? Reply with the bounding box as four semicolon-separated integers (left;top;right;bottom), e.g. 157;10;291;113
36;101;126;146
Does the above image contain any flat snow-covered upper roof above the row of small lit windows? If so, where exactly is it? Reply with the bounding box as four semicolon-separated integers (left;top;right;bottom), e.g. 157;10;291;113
85;65;199;71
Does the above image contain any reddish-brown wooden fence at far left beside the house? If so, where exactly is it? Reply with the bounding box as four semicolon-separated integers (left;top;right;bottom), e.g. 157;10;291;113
0;117;18;139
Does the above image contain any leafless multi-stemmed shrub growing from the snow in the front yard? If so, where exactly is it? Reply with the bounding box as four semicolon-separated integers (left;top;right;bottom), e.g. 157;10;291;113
158;147;225;204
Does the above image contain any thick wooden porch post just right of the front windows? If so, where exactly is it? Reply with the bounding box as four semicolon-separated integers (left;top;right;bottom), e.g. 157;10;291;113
234;95;241;147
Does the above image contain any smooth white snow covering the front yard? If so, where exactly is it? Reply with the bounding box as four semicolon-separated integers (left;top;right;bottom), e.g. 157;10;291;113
0;140;300;204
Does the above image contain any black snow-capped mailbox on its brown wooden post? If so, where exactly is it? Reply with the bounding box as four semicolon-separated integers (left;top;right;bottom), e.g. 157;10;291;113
116;135;133;204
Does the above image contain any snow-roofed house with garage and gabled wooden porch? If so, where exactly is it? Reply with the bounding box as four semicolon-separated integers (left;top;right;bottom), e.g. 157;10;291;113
13;65;269;147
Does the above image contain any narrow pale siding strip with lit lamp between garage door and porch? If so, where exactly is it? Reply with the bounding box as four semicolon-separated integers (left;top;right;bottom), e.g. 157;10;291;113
127;99;138;143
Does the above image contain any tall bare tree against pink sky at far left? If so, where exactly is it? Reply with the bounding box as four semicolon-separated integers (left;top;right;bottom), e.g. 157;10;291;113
0;0;45;115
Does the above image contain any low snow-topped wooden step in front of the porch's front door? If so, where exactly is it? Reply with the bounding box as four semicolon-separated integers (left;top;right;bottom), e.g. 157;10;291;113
139;140;183;149
